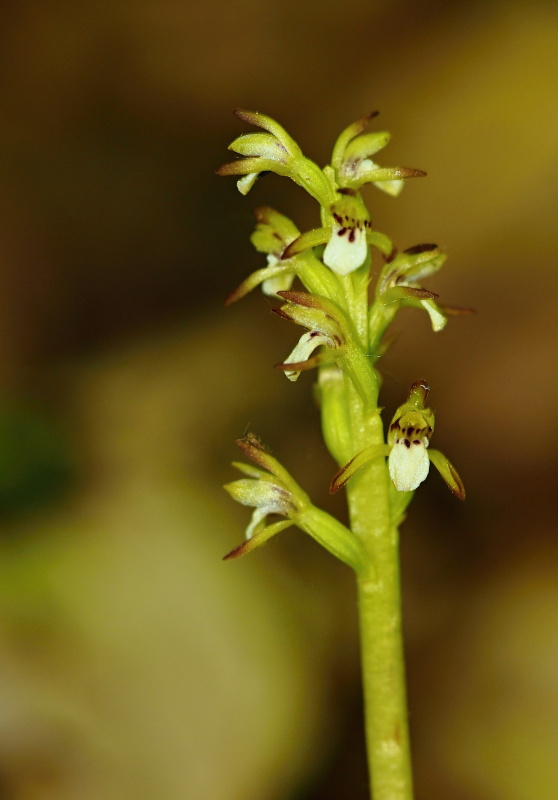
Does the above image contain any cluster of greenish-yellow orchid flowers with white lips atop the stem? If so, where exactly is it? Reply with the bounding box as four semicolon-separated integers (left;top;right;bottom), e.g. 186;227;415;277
217;111;469;563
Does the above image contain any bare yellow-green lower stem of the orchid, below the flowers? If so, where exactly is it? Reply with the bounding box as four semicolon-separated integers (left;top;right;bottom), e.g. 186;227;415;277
346;380;413;800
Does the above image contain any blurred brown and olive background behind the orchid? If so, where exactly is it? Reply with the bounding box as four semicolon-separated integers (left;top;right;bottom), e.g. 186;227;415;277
0;0;558;800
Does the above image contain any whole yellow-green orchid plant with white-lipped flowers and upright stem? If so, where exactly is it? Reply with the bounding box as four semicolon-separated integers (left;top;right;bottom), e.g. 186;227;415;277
217;111;467;800
